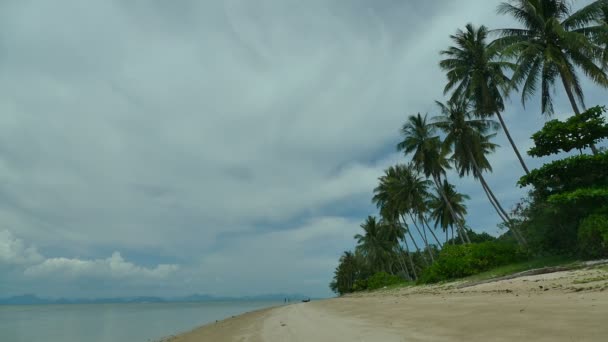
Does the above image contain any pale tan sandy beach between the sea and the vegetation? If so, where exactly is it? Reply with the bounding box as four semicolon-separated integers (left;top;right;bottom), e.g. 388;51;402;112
167;266;608;342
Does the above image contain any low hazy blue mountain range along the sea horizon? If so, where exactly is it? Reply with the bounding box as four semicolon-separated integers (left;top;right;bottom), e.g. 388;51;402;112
0;294;308;305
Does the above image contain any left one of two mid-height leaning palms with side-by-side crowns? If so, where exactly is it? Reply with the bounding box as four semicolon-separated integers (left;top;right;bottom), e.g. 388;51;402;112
397;113;470;242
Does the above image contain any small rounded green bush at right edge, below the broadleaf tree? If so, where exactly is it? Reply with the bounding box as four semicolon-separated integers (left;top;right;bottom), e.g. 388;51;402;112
578;214;608;258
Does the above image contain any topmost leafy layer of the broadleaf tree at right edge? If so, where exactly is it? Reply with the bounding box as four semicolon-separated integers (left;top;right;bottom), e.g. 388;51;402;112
528;106;608;157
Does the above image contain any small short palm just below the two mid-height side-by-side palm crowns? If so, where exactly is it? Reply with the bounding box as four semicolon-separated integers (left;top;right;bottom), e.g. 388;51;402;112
429;180;469;243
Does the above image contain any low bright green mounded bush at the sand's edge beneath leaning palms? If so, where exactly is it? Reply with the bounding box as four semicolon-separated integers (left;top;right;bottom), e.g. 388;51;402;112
419;242;524;283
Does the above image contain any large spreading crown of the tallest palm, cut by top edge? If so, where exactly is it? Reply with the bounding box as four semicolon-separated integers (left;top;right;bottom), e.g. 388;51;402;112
494;0;608;125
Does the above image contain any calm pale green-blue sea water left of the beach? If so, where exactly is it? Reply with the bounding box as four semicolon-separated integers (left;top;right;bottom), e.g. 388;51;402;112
0;301;281;342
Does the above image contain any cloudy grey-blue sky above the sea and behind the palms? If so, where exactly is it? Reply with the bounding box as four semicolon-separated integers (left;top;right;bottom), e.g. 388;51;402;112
0;0;606;298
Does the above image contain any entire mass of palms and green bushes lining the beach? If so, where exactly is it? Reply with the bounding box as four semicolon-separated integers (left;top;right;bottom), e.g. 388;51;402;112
330;0;608;294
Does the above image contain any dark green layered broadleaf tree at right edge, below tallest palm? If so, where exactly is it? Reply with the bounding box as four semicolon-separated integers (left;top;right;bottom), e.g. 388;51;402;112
513;107;608;256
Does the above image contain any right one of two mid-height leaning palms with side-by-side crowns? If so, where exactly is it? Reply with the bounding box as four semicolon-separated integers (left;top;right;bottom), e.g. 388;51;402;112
434;99;525;244
